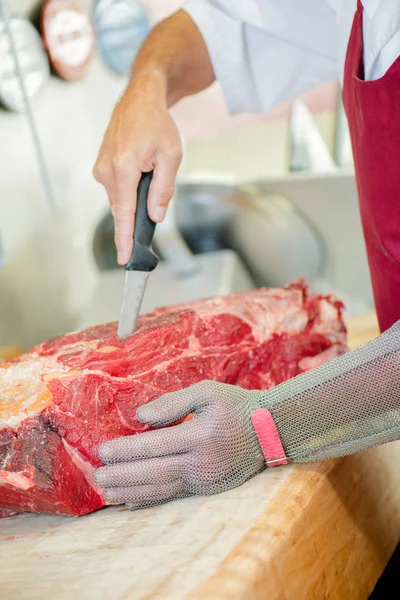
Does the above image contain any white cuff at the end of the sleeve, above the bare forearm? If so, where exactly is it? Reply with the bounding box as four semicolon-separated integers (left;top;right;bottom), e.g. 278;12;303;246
182;0;262;114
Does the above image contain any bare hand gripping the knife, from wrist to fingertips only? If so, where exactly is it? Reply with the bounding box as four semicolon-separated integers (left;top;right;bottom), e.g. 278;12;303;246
93;74;182;265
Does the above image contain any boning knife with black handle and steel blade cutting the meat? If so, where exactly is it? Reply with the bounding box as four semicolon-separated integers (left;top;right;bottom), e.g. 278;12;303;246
118;172;158;339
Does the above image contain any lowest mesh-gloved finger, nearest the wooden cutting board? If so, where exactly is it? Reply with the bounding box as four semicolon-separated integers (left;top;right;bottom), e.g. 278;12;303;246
104;481;185;510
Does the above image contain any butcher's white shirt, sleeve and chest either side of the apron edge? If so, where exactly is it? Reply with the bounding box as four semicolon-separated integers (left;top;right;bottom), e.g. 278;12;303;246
183;0;400;113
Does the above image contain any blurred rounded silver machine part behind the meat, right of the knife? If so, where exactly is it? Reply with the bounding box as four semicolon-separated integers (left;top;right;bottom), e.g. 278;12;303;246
175;177;323;286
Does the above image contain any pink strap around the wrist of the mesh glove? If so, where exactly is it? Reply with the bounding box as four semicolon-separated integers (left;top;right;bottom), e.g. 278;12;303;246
251;408;289;467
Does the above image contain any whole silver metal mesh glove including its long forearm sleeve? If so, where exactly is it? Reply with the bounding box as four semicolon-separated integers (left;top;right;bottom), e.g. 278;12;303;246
96;324;400;508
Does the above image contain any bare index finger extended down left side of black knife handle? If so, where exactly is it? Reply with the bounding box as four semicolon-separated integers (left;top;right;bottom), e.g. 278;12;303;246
110;163;142;265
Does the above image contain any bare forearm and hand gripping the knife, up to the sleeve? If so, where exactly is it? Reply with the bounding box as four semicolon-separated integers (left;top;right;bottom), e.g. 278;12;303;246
93;10;215;265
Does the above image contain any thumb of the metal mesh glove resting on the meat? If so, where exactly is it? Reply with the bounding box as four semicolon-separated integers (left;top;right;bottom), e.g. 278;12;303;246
136;381;214;427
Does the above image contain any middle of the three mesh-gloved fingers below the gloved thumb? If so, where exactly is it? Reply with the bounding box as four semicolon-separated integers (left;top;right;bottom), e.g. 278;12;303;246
94;455;184;488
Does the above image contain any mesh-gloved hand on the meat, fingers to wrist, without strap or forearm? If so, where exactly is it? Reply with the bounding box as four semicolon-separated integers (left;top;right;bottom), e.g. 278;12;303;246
95;381;265;509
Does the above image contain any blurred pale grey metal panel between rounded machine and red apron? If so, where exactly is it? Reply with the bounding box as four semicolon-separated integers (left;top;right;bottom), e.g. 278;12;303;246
257;169;374;314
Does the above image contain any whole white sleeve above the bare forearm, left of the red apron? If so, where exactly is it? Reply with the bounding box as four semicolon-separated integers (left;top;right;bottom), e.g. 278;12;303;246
182;0;338;113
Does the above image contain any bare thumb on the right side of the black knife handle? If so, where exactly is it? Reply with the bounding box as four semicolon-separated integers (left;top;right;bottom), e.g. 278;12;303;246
148;153;181;223
